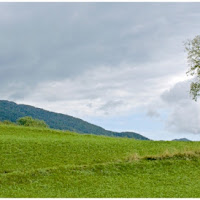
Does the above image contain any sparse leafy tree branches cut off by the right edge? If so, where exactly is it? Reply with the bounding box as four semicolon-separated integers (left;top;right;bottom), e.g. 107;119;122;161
185;35;200;101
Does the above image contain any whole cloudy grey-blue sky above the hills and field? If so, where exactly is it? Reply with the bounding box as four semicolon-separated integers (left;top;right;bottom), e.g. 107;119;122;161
0;3;200;140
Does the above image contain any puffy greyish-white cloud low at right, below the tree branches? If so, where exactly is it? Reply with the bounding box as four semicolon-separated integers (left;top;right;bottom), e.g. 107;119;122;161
162;80;200;134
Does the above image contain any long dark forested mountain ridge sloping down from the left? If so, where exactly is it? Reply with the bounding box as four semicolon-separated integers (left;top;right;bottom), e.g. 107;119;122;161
0;100;149;140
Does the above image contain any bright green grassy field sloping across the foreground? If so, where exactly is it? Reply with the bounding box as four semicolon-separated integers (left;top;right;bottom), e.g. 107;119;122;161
0;125;200;198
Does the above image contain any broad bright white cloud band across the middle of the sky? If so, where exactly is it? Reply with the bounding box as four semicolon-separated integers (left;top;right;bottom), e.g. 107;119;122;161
18;55;188;117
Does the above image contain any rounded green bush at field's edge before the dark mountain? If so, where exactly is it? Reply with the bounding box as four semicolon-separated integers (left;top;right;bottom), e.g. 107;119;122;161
17;116;48;128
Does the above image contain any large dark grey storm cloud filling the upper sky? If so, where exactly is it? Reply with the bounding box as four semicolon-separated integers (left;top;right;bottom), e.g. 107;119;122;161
0;3;200;99
